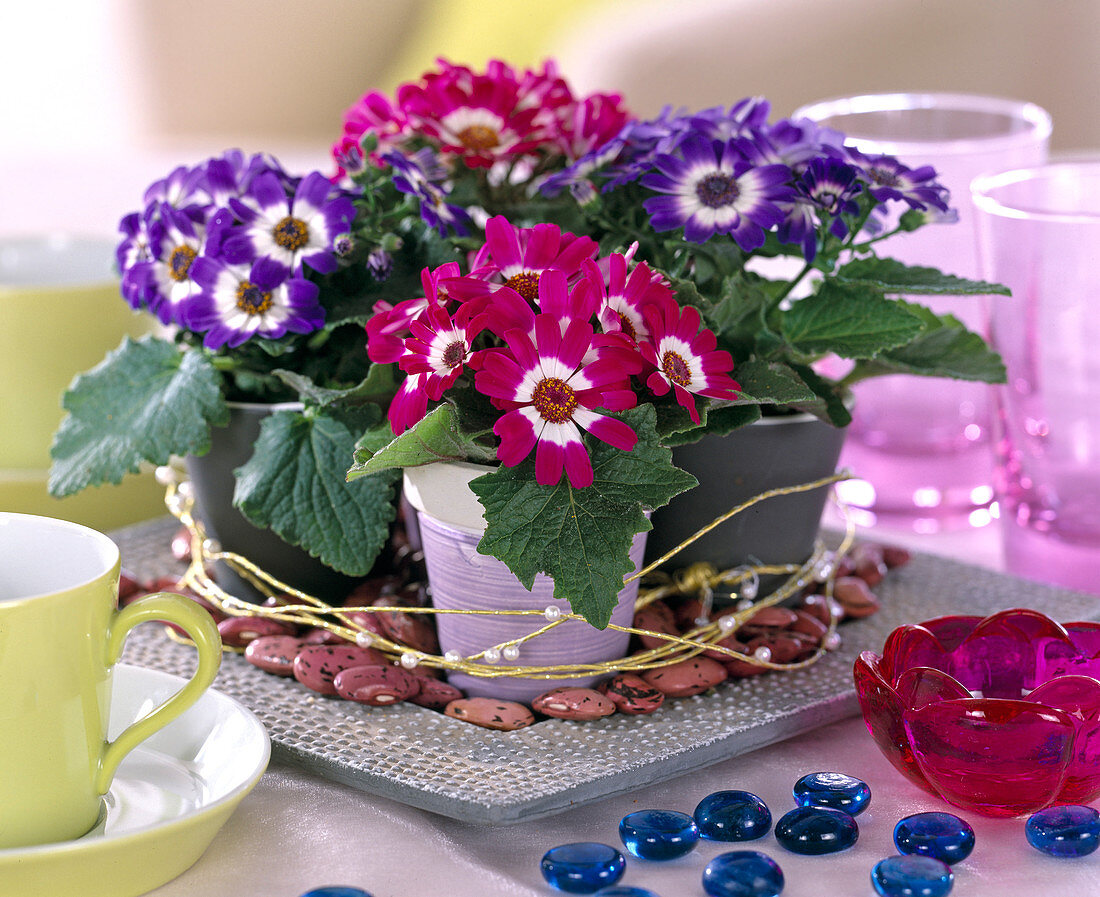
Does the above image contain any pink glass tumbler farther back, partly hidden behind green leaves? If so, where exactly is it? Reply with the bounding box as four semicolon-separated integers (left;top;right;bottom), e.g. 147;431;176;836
794;94;1051;532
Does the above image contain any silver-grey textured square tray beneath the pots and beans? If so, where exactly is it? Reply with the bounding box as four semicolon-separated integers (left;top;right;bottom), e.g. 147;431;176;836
112;518;1100;824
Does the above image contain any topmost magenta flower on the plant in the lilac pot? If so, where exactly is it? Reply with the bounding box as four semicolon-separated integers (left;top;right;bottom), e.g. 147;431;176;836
455;215;600;303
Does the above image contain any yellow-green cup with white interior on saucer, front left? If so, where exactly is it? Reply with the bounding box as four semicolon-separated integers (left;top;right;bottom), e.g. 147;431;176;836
0;512;221;849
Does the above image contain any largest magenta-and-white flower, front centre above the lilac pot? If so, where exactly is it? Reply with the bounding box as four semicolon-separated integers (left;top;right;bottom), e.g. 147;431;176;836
475;278;640;489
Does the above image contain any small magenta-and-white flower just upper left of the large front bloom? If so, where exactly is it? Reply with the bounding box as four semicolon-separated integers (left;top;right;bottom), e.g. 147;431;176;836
400;300;484;402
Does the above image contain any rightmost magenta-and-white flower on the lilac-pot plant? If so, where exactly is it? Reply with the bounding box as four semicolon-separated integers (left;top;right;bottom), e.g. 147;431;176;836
638;298;740;424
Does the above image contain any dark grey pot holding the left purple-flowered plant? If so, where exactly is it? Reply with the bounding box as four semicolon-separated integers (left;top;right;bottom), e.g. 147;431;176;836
186;403;358;604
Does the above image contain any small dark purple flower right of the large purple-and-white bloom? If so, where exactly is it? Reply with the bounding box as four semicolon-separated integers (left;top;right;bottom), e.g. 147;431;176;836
777;157;862;262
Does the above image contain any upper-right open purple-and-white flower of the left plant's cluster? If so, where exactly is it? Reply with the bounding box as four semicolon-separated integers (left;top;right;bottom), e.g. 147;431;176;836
221;169;355;274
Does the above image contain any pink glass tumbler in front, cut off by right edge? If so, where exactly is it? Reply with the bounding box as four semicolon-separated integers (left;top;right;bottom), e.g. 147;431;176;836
974;156;1100;594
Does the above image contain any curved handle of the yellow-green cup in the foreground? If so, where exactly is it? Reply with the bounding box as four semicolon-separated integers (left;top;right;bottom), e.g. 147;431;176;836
96;592;221;795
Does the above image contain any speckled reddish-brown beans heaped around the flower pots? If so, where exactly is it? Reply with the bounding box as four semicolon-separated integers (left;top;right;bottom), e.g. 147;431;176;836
120;536;910;730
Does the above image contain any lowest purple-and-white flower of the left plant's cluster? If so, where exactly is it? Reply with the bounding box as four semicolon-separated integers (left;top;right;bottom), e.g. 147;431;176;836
184;255;325;349
